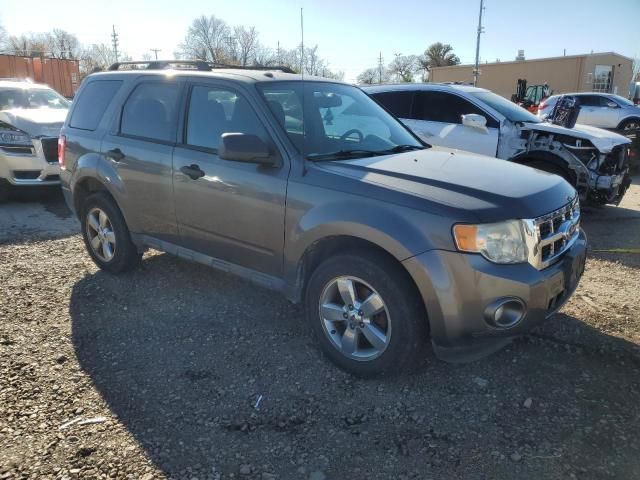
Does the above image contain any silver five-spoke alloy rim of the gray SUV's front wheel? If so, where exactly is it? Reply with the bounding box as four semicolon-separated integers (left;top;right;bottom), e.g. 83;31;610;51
319;276;391;361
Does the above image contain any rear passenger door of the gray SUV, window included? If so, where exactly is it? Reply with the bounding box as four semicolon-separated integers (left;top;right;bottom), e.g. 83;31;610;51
101;77;184;242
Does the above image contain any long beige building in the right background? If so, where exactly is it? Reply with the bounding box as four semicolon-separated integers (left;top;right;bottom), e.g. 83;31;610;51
429;52;633;98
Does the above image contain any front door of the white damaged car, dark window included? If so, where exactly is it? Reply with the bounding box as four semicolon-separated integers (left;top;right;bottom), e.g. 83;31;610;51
405;90;499;157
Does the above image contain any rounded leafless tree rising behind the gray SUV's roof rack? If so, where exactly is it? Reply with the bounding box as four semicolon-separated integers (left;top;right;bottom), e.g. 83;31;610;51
179;15;231;63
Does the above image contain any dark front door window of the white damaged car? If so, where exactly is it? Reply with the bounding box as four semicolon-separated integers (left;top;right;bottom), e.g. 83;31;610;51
412;92;498;128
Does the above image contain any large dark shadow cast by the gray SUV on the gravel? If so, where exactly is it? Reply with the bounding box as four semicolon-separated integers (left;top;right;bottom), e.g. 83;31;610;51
70;255;640;479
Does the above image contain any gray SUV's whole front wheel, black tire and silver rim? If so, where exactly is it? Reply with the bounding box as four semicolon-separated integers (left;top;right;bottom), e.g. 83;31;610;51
305;249;427;377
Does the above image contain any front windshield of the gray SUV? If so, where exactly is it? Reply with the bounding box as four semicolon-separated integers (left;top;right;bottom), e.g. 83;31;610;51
258;82;425;159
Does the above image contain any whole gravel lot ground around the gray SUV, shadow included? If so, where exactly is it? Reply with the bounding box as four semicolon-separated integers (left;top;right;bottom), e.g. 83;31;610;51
0;181;640;480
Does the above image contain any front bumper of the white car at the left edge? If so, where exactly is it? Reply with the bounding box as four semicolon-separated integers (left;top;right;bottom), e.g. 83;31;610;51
0;139;60;187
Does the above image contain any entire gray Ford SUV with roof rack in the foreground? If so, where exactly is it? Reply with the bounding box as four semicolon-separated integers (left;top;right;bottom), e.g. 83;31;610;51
60;61;587;376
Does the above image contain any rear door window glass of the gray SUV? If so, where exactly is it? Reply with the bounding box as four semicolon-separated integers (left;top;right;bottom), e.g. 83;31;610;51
120;82;180;142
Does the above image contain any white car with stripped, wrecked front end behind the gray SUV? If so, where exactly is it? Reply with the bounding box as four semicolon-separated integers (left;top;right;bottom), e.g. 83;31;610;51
364;83;631;205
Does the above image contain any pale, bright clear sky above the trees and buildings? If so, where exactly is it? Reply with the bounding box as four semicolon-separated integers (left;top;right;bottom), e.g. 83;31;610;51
0;0;640;81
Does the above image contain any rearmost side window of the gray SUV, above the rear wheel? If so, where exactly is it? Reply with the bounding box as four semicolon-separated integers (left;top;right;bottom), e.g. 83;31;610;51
69;80;122;130
